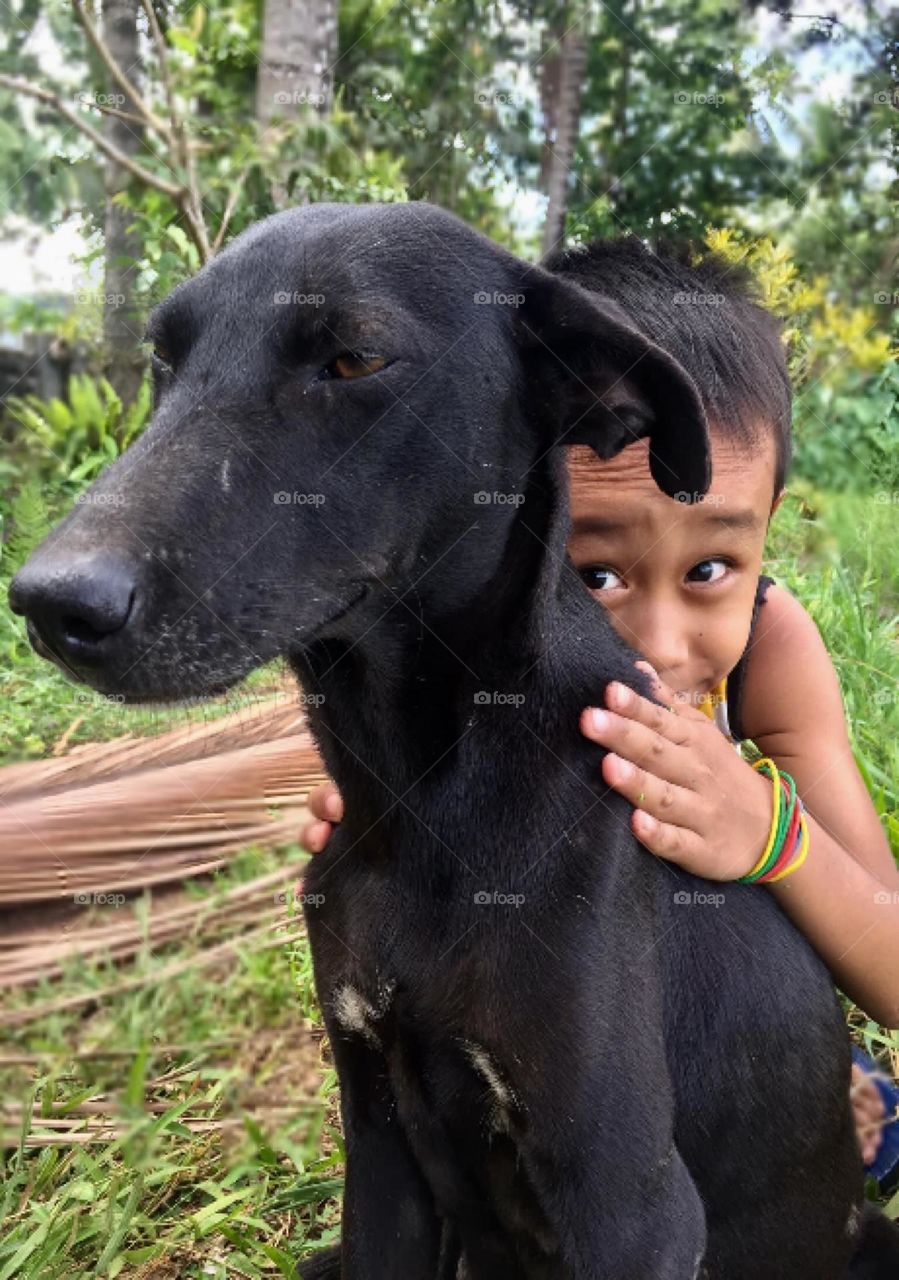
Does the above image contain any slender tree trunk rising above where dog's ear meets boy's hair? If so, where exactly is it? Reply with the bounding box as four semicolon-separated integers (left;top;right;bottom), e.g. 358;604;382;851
540;14;587;256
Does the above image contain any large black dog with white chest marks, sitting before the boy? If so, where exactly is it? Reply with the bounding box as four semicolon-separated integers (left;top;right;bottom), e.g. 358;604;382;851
10;204;899;1280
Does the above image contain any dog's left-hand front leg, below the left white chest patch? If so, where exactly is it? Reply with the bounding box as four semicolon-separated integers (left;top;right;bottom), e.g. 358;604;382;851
332;1028;442;1280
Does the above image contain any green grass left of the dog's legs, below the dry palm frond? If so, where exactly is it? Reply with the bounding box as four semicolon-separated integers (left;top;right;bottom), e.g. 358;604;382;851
0;846;343;1280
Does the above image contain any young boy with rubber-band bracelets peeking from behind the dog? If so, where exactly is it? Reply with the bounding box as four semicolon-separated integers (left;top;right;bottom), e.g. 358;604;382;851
302;238;899;1166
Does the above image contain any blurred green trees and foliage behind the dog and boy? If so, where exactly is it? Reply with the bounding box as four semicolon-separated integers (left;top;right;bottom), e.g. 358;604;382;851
0;0;899;759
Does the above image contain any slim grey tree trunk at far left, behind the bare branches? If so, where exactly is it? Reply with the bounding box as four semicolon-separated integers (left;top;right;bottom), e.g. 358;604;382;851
102;0;145;404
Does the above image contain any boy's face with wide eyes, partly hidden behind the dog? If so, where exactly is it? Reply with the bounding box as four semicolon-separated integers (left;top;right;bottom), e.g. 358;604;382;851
569;430;780;698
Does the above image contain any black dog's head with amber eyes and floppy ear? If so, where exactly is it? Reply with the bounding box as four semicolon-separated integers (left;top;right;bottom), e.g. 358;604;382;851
10;204;708;700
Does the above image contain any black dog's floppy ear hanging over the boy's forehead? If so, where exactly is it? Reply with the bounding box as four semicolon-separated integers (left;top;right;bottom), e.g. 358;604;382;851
516;266;711;502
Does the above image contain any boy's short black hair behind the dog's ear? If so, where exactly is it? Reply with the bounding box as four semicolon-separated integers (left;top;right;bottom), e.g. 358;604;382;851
543;236;793;494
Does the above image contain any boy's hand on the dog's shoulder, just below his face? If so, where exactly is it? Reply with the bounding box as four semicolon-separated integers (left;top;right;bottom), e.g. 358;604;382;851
580;663;771;881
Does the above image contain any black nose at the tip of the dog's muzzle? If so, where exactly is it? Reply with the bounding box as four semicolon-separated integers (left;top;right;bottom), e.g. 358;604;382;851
9;550;137;666
